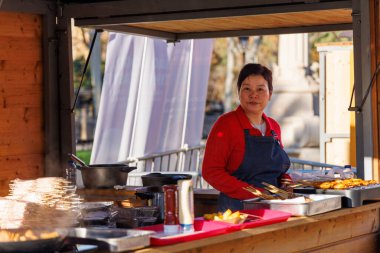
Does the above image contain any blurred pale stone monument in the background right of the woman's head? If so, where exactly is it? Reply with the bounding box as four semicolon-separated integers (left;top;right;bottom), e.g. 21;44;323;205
266;34;320;161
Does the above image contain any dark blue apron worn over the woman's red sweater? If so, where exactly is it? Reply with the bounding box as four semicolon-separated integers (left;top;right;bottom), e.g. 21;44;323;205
218;129;290;212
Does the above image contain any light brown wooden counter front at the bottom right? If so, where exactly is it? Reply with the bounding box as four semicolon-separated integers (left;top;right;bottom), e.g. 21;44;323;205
135;202;380;253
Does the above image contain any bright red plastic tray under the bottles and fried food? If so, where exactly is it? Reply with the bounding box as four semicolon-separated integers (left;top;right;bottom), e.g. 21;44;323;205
139;209;291;246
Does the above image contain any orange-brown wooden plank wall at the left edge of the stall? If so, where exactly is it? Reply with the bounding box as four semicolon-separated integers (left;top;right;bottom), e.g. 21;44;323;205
0;12;44;196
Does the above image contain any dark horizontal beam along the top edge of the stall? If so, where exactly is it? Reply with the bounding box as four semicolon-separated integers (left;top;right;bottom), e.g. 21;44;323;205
62;0;351;18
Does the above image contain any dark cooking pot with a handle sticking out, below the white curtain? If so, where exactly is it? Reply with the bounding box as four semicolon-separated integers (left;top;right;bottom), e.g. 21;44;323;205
69;154;136;188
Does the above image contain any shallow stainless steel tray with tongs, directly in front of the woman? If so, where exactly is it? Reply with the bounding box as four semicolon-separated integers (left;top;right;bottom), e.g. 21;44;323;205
243;194;342;216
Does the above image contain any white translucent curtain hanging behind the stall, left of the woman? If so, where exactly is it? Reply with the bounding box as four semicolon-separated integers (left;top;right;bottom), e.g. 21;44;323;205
91;33;212;164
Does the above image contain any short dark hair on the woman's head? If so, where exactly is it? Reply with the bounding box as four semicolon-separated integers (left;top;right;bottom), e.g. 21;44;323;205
237;63;273;92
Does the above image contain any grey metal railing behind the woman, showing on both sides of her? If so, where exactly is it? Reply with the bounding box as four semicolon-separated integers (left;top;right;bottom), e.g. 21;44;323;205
125;145;343;189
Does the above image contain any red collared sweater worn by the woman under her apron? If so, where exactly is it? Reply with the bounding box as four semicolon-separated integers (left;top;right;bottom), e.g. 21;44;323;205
202;106;288;199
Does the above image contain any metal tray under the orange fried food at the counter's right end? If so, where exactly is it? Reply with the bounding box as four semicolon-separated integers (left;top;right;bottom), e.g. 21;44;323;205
294;184;380;207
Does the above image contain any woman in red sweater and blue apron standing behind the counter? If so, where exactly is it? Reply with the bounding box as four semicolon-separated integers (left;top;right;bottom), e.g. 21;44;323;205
202;63;290;211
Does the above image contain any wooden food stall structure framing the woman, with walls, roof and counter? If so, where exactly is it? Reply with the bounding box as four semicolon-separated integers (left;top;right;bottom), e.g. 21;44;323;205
0;0;380;253
